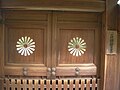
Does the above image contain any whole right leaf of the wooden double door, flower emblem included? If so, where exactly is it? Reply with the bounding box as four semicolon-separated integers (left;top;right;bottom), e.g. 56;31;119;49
52;12;100;76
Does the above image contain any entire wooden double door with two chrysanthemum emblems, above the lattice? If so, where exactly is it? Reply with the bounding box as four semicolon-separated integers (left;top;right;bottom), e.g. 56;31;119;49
3;10;102;78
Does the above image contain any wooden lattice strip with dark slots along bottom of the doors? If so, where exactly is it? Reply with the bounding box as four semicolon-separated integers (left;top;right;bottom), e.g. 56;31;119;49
2;77;100;90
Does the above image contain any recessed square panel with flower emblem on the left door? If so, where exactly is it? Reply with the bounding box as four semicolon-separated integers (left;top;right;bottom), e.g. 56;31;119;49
6;28;45;64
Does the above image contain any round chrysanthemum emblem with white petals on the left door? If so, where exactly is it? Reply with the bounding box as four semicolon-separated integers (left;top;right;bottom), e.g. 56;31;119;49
16;36;35;56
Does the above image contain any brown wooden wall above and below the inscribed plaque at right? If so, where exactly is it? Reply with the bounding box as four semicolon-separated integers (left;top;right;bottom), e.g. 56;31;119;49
104;0;119;90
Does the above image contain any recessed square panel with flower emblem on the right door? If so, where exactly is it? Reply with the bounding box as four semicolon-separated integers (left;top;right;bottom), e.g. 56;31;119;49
58;29;95;64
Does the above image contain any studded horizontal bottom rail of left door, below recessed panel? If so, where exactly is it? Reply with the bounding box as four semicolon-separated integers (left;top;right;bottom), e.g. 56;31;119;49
4;66;47;76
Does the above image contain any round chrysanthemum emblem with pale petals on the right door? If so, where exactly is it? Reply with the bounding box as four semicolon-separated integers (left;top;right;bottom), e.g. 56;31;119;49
68;37;86;56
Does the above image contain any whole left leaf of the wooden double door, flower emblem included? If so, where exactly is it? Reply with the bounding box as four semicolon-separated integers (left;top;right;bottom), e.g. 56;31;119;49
3;11;51;76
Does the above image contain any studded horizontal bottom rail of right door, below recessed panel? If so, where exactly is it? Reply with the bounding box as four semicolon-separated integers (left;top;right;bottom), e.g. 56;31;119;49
56;64;97;76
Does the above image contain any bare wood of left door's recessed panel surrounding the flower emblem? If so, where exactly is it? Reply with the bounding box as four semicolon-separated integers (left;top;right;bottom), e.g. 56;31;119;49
6;28;46;64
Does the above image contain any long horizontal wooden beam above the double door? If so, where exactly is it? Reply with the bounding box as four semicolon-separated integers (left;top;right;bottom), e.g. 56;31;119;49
1;0;105;12
